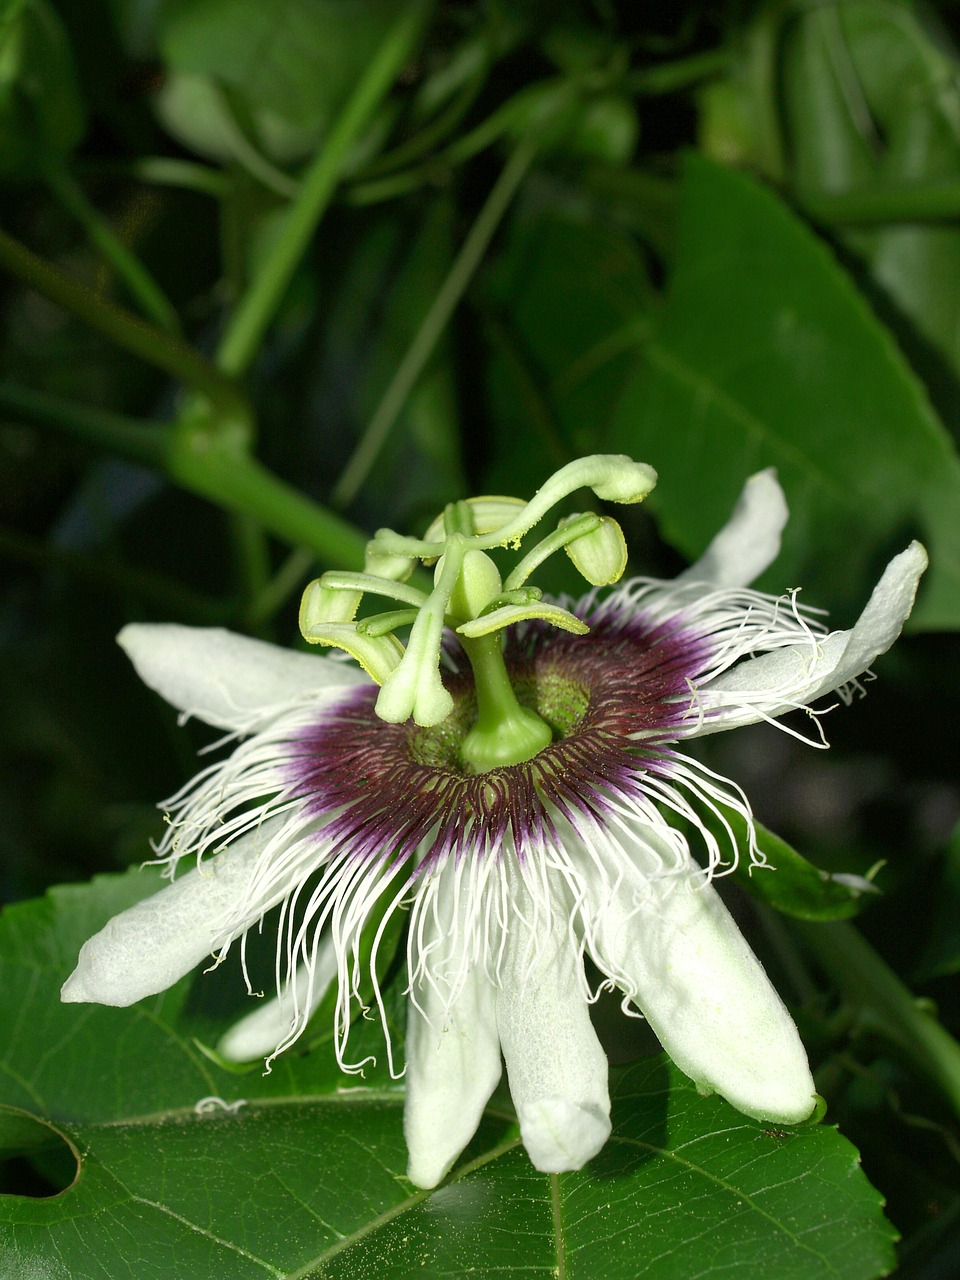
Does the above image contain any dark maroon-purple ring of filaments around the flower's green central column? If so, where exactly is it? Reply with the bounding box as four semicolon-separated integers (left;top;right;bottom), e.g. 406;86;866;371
289;612;710;863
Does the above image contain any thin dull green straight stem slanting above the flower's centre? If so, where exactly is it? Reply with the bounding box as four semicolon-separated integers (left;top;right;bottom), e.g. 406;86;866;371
330;135;536;507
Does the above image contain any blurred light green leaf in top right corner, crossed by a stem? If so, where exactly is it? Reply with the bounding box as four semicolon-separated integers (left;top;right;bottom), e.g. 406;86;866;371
782;0;960;424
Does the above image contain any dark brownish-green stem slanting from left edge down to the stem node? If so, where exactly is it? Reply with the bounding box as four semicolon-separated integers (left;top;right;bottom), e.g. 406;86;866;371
0;230;252;430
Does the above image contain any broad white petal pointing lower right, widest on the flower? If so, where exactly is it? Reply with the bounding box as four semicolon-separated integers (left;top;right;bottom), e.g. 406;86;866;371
586;828;814;1124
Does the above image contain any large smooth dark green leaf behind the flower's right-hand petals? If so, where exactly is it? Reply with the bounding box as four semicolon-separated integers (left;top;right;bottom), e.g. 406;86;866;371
608;157;960;628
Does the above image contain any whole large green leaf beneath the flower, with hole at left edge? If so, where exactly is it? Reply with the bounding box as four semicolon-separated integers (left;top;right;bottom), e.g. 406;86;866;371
0;873;892;1280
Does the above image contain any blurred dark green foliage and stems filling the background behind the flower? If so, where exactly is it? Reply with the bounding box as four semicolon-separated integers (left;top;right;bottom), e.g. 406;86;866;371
0;0;960;1280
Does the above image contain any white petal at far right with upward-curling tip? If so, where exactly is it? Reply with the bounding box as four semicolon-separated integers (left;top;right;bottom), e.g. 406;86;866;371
692;543;927;736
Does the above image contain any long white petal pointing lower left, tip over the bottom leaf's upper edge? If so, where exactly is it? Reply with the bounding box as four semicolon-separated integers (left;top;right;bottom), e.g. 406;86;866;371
60;823;283;1007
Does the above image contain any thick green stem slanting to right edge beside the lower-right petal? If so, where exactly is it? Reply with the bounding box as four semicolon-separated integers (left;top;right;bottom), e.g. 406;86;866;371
791;920;960;1116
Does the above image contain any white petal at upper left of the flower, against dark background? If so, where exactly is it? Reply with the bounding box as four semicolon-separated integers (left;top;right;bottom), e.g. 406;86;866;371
116;623;369;732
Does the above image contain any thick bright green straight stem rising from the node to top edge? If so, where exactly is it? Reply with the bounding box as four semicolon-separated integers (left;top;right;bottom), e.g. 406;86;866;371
216;0;428;376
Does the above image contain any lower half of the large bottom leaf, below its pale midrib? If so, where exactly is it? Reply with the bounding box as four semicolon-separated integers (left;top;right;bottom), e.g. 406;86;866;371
0;1059;891;1280
